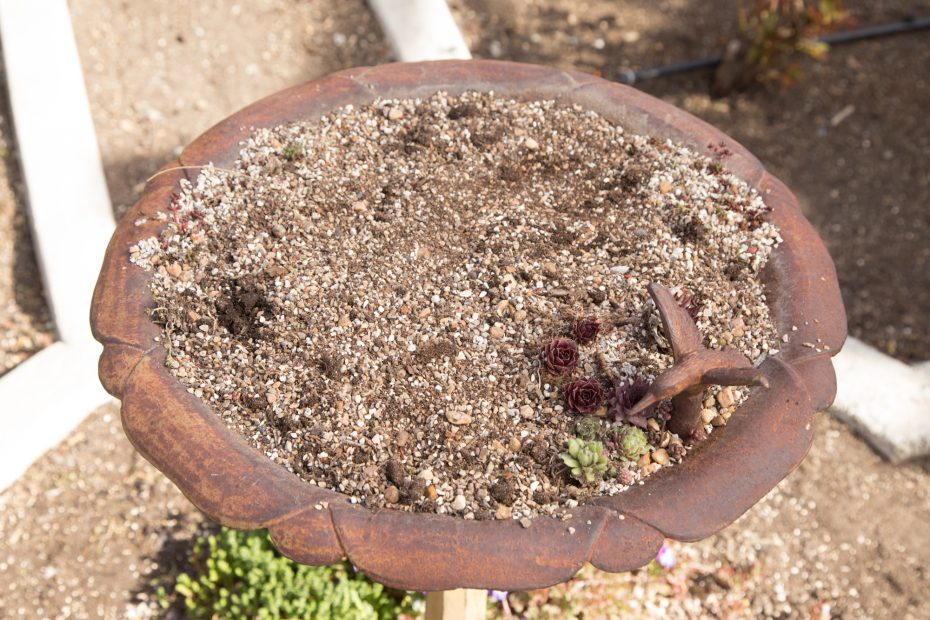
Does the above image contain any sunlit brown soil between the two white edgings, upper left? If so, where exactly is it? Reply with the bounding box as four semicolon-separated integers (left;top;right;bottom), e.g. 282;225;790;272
69;0;390;216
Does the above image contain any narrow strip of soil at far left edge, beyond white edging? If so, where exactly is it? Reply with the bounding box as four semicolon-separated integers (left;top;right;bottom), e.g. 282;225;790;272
0;66;54;376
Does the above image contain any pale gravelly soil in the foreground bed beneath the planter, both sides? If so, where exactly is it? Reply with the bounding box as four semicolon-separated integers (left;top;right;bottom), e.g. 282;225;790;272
0;405;930;620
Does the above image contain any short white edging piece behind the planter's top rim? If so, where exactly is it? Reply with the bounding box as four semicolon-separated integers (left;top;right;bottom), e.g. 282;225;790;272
368;0;471;62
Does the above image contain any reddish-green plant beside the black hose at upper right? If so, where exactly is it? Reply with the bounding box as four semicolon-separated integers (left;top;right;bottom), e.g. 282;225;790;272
739;0;850;84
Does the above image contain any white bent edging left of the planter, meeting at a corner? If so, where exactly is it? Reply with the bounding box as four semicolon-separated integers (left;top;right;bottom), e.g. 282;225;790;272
0;0;114;490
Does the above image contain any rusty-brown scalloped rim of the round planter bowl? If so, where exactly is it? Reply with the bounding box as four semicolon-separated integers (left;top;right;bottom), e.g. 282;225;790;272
91;61;846;591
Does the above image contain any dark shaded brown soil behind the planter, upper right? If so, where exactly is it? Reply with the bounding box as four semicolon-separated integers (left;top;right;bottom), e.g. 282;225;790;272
451;0;930;362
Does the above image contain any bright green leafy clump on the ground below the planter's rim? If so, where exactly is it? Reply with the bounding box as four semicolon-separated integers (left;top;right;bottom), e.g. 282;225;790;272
159;528;414;620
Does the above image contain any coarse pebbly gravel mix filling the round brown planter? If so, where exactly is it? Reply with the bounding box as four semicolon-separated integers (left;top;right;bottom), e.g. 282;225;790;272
132;93;788;518
